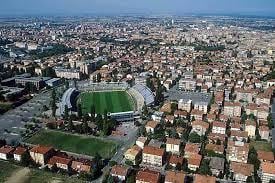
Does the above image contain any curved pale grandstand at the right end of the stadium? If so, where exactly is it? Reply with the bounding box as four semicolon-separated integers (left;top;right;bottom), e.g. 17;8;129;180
132;84;155;106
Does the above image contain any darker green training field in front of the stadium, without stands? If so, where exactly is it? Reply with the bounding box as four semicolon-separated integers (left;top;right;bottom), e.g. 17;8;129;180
26;130;117;158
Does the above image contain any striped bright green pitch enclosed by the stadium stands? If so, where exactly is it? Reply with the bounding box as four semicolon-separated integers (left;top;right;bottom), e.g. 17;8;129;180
78;91;134;114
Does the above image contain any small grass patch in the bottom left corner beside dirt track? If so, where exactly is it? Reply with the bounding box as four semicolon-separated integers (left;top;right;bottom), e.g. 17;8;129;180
0;161;20;182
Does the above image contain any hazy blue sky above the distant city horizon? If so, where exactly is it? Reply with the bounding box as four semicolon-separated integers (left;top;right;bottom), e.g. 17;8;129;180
0;0;275;15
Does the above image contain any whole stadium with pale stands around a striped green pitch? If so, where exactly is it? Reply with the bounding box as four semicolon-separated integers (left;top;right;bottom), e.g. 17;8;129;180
60;82;154;122
